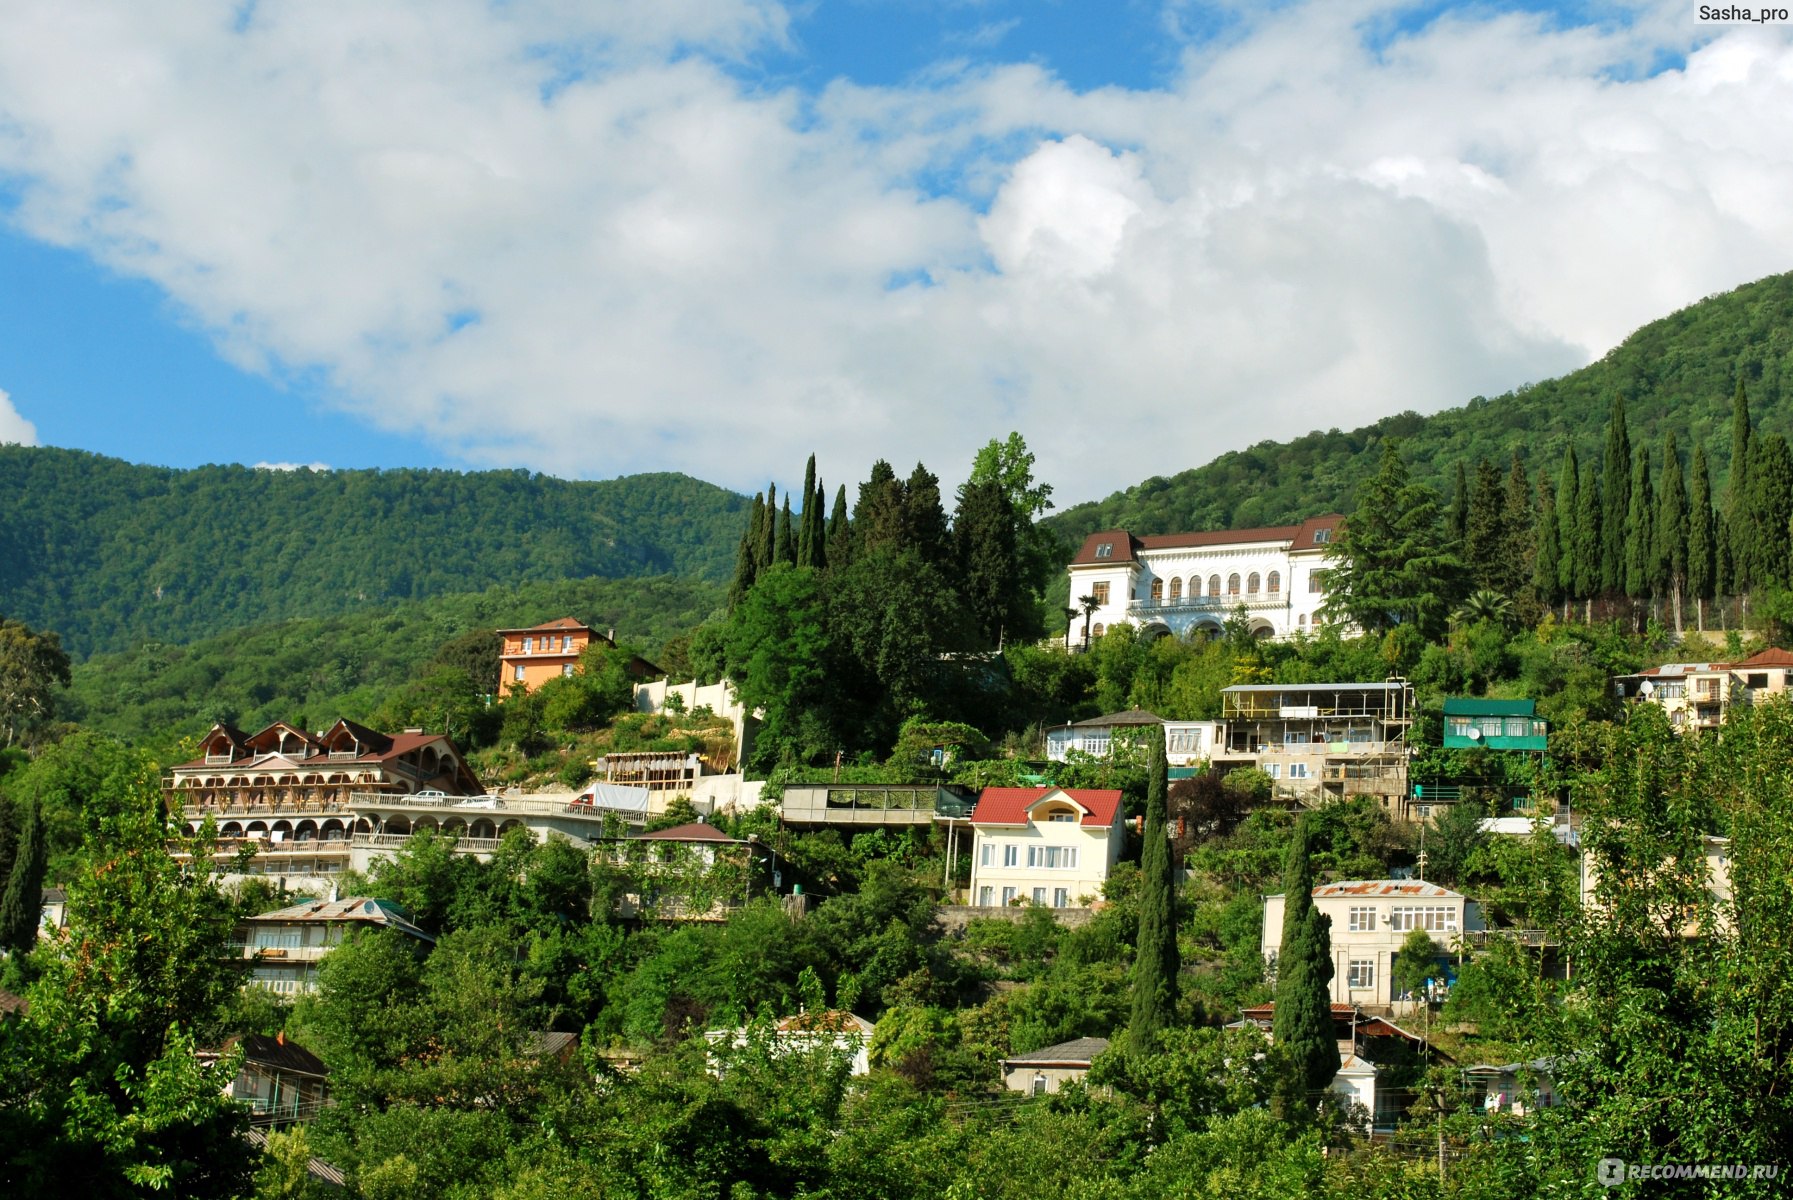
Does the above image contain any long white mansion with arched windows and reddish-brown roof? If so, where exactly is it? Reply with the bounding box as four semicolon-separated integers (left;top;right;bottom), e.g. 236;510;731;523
1070;513;1345;646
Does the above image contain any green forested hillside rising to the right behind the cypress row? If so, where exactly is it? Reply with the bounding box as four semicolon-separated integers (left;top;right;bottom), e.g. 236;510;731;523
1051;274;1793;540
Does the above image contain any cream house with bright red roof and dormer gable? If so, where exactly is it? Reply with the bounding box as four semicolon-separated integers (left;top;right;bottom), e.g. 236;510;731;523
972;787;1126;908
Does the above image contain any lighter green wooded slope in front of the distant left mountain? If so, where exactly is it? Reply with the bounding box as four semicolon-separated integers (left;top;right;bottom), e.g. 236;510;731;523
63;578;723;739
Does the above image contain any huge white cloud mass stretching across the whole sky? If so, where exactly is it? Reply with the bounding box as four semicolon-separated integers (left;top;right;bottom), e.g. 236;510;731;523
0;0;1793;500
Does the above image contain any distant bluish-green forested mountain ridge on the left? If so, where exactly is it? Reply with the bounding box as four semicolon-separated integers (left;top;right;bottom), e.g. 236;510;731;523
0;445;746;657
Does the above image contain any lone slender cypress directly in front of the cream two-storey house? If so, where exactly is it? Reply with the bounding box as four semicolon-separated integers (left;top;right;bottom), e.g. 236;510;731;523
1271;818;1339;1123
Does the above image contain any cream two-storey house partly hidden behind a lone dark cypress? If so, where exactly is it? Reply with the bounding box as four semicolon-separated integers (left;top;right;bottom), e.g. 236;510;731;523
1262;879;1486;1012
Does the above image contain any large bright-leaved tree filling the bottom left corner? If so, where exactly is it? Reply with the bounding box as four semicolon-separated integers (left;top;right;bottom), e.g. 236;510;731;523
0;786;253;1196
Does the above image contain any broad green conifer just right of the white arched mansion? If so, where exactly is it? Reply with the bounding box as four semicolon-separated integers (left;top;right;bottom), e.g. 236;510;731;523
1325;441;1463;637
